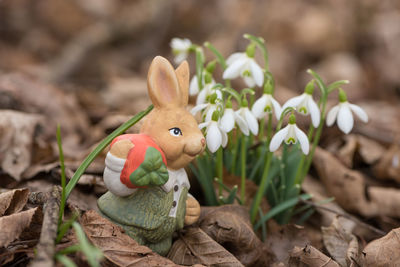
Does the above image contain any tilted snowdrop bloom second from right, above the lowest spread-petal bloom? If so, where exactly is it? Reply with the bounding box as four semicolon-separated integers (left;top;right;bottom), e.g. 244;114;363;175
282;81;321;128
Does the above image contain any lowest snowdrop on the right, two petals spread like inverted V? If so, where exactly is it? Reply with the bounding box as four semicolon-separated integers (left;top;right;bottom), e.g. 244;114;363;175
269;114;310;155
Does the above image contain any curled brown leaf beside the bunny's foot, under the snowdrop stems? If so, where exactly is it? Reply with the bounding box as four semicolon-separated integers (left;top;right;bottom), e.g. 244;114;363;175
200;205;273;266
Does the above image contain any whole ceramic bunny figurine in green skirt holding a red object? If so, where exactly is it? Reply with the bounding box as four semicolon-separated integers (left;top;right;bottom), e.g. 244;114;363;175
98;56;206;255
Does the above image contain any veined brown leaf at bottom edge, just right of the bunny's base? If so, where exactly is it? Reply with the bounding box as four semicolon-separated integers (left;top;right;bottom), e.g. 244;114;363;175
167;227;243;267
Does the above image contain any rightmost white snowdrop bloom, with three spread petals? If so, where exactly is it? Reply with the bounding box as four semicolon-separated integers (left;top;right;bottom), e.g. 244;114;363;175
326;89;368;134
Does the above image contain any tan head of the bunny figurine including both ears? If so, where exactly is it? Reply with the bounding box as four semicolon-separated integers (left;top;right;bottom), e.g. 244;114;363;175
140;57;205;169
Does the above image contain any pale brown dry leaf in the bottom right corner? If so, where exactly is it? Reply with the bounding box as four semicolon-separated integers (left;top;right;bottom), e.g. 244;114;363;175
362;228;400;267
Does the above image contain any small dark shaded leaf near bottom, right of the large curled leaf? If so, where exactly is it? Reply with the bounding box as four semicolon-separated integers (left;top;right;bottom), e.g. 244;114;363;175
265;224;310;262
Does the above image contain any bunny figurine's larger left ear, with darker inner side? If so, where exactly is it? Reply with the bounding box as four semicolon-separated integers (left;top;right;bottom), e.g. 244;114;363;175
147;56;181;107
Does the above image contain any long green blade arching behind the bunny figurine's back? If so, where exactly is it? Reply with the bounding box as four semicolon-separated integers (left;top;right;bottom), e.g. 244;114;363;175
65;105;153;199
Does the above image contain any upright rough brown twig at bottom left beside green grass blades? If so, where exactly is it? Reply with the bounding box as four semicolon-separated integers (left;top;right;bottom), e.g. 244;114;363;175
30;186;61;267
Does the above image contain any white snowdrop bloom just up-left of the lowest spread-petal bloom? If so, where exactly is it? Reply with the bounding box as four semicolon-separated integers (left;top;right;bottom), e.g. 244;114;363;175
251;82;282;120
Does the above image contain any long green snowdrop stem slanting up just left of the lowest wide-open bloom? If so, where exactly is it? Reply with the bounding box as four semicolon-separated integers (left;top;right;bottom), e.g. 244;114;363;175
250;113;273;224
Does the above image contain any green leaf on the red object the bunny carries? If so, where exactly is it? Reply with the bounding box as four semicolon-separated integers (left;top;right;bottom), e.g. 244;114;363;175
129;147;169;186
